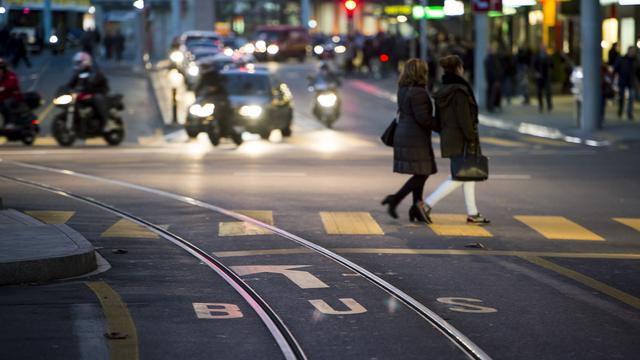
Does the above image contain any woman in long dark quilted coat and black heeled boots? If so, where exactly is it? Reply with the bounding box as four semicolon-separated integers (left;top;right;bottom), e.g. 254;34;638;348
382;59;437;223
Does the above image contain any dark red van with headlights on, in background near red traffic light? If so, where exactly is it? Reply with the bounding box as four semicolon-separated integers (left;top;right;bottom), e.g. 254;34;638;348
253;25;310;62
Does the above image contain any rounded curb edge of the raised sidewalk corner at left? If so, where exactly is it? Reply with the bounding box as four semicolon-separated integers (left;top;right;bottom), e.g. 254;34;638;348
0;225;97;285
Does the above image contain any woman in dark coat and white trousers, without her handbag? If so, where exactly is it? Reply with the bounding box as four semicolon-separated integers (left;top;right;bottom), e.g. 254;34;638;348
424;55;490;225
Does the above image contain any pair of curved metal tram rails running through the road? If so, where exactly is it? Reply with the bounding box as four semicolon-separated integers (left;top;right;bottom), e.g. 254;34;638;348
0;159;491;360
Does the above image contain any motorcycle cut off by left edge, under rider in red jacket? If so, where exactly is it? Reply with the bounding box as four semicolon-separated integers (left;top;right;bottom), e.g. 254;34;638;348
0;92;42;145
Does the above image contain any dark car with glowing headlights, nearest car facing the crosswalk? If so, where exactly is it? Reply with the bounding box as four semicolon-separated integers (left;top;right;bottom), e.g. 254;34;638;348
185;66;293;145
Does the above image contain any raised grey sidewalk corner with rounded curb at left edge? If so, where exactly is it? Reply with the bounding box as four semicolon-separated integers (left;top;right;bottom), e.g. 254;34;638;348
0;209;97;285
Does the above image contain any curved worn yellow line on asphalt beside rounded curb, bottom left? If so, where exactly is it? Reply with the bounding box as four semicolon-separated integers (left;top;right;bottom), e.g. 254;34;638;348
86;281;139;360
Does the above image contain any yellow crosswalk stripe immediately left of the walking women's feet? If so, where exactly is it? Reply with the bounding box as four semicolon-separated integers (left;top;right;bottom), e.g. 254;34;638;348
320;212;384;235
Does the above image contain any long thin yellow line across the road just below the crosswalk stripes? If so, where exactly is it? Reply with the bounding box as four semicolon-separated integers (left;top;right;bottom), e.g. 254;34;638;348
214;247;640;260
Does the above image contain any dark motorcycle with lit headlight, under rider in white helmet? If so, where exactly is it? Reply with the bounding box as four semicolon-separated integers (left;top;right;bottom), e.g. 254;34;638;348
51;79;124;146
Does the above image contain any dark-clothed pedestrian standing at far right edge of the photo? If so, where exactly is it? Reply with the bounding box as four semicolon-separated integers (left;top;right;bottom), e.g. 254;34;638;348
614;46;639;120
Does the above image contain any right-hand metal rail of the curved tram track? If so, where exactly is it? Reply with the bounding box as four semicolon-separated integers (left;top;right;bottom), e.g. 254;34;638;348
0;159;491;360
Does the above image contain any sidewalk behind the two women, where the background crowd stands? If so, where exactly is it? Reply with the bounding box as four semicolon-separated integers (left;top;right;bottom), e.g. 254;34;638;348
346;76;640;146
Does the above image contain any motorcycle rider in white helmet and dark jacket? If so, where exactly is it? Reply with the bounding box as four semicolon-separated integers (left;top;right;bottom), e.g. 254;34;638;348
66;52;109;132
